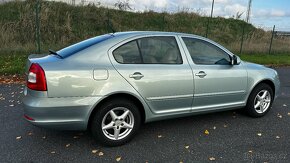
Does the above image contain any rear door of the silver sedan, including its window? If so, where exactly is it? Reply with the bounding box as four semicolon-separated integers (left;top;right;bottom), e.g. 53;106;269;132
109;36;193;114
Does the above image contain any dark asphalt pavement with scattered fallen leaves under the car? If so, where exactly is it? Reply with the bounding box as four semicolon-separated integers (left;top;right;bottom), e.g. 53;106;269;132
0;68;290;163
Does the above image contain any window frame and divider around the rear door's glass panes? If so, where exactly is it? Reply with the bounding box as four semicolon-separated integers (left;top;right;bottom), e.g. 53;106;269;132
110;35;184;65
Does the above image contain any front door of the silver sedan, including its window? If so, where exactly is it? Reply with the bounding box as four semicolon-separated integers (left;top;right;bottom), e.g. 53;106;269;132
182;37;247;111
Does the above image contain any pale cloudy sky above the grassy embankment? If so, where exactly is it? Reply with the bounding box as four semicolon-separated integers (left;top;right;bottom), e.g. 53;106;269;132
100;0;290;31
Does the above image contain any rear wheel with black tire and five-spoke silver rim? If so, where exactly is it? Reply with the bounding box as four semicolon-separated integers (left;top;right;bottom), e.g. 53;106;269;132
90;98;141;146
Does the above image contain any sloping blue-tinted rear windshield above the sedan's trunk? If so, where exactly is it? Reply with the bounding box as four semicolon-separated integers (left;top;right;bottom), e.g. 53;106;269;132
57;34;114;58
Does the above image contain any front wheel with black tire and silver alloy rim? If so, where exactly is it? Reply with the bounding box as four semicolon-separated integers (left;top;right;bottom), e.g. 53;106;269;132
245;83;274;117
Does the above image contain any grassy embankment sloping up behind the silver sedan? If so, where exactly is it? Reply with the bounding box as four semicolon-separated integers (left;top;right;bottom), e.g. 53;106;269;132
0;0;258;52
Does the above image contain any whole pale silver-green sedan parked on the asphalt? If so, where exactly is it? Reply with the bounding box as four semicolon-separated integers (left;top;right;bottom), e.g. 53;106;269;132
23;31;280;146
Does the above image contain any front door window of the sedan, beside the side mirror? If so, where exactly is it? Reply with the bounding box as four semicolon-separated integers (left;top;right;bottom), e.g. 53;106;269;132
182;37;230;65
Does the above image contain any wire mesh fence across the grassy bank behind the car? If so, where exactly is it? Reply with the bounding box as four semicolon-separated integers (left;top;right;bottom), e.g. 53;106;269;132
0;0;290;54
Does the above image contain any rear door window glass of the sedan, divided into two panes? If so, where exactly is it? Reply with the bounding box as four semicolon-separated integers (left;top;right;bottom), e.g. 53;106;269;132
113;36;182;64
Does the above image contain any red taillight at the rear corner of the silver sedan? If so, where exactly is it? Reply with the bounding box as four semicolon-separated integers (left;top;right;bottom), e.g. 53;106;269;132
27;63;47;91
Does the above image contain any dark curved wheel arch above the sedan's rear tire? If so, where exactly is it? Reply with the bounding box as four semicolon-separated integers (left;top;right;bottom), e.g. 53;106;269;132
87;93;146;129
